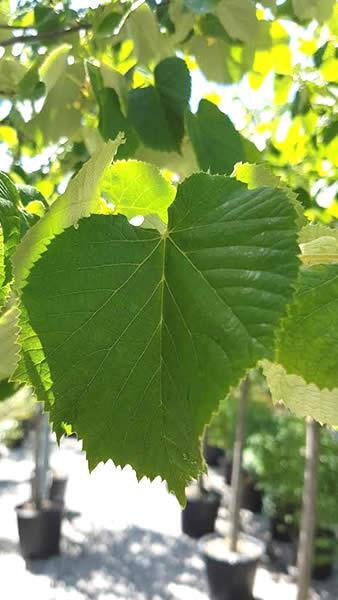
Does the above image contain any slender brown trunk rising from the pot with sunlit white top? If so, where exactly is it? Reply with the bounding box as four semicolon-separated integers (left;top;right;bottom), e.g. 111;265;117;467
229;377;249;552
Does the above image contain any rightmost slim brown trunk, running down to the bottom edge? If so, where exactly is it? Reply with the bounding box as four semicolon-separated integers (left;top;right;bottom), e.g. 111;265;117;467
297;418;320;600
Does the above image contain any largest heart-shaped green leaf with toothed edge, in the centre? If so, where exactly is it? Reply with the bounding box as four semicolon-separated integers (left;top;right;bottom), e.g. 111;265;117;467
22;174;298;502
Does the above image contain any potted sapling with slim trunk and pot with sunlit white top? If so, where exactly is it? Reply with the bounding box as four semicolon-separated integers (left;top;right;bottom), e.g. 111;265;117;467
200;378;264;600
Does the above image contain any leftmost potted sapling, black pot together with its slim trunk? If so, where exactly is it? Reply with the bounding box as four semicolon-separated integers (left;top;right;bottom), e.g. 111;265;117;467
16;412;63;559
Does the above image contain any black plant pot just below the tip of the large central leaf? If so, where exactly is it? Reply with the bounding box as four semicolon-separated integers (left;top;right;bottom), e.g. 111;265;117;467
182;490;221;539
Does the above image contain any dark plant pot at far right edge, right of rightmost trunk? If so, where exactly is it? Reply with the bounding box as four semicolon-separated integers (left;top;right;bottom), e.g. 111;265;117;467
312;528;337;579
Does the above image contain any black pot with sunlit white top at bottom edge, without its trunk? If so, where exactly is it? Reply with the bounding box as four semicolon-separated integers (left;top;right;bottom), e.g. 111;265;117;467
199;534;264;600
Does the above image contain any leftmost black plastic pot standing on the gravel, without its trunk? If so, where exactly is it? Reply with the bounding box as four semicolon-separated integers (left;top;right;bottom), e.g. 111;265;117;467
16;502;62;559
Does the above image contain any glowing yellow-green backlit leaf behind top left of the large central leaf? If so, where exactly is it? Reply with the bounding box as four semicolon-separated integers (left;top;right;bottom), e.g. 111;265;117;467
101;160;176;222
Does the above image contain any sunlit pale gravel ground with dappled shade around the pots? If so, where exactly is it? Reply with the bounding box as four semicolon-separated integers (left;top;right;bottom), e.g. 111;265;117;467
0;439;338;600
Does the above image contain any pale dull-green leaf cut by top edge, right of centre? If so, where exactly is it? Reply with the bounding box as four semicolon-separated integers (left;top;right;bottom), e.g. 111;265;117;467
216;0;258;42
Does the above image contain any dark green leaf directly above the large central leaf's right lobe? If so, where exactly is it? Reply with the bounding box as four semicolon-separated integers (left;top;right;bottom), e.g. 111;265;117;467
187;100;244;175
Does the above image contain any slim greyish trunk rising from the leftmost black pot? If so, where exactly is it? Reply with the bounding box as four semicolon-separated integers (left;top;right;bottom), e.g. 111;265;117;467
32;412;49;509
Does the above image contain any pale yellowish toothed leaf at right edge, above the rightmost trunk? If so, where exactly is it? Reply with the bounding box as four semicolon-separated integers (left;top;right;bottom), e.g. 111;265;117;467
261;360;338;427
